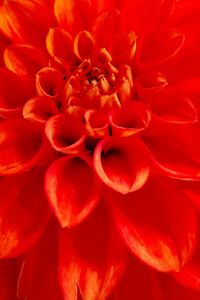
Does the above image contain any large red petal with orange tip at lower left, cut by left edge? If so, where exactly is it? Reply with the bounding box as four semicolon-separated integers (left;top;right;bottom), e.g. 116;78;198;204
0;169;49;257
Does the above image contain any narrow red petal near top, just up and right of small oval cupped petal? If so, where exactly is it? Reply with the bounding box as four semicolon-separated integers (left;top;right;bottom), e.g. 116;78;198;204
93;9;120;47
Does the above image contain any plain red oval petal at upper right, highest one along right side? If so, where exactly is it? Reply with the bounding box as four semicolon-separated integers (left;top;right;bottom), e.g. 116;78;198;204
138;28;185;65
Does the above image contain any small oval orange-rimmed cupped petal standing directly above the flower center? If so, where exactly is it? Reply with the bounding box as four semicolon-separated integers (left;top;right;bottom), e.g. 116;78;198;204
74;31;94;60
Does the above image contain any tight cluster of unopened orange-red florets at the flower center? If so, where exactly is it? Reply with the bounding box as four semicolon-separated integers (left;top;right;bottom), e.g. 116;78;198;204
62;41;133;110
